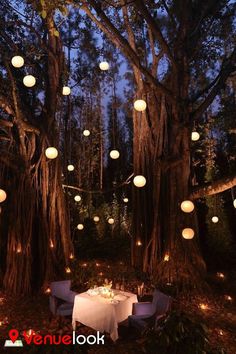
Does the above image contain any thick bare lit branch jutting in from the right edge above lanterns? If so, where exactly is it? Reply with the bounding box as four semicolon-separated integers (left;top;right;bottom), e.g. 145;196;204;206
190;175;236;199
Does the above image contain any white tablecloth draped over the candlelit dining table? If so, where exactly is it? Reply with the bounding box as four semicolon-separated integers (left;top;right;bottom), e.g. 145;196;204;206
72;290;138;341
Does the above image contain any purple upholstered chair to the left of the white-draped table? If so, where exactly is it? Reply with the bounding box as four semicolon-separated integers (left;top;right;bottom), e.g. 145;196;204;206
49;280;77;316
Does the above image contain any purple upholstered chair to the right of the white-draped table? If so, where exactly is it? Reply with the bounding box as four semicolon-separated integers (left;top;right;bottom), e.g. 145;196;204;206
128;290;172;332
